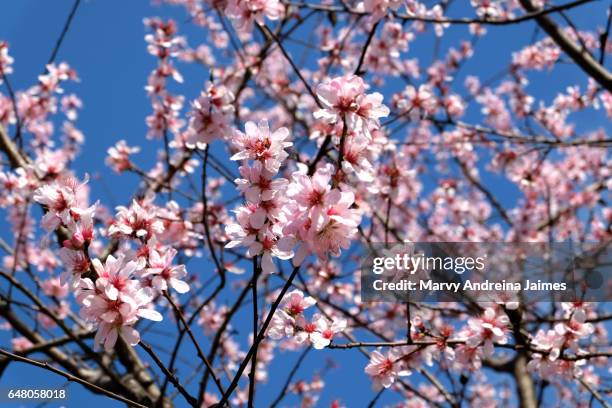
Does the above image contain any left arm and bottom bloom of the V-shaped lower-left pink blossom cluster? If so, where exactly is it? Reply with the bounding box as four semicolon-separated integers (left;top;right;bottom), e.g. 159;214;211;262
33;177;166;350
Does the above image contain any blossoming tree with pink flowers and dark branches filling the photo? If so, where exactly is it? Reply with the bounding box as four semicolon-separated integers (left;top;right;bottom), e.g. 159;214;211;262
0;0;612;407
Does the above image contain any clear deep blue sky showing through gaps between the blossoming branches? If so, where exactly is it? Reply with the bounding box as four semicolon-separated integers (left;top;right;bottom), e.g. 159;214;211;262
0;0;610;407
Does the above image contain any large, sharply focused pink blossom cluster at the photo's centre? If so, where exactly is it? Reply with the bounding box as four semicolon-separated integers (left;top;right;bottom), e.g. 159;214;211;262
226;117;361;272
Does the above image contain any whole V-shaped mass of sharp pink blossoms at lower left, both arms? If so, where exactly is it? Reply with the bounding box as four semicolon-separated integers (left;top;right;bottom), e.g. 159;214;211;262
33;177;190;350
